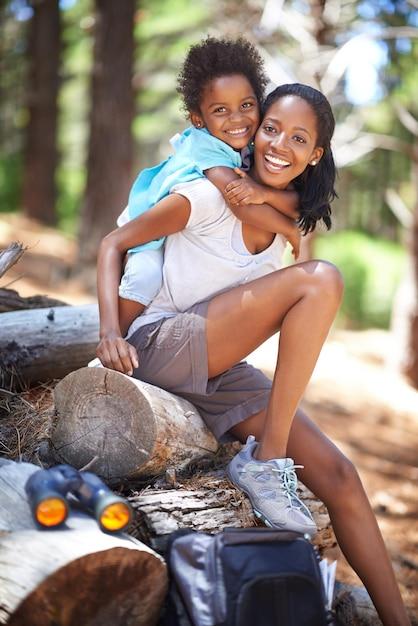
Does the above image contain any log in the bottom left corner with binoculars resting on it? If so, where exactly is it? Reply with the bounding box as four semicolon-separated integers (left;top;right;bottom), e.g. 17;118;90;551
0;460;167;626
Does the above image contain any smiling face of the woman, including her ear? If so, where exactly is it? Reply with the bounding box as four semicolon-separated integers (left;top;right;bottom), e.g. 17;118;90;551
254;96;324;189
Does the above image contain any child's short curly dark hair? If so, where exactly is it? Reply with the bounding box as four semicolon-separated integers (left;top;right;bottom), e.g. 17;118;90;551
177;37;268;112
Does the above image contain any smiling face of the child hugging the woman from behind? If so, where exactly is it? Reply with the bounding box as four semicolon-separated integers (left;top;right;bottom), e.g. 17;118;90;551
190;74;260;150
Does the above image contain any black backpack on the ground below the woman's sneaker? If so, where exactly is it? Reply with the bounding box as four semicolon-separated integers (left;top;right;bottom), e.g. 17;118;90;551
161;528;335;626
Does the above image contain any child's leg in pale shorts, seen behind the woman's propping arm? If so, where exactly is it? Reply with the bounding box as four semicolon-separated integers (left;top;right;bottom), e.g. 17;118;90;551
119;248;164;337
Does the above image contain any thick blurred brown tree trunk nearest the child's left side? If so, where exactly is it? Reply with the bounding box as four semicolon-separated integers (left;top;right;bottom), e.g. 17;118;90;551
79;0;136;268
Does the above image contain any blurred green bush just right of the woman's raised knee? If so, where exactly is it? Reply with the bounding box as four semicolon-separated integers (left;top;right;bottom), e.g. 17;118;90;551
315;231;406;328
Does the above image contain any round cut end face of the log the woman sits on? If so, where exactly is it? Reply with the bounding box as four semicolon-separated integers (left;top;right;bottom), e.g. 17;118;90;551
52;368;156;479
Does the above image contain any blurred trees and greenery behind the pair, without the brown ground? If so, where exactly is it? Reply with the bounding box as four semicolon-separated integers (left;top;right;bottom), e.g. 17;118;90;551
0;0;418;387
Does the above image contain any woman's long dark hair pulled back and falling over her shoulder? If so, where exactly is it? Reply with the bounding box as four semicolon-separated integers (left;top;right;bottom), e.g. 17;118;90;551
263;83;337;235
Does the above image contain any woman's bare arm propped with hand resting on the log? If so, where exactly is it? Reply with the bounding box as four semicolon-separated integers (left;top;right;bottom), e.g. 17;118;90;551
96;194;190;375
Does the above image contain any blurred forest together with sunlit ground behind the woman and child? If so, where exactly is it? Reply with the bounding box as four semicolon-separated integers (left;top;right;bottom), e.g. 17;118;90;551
0;0;418;626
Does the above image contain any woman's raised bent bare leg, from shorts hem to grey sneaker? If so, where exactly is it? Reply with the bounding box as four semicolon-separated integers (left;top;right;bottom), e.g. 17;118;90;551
206;261;342;460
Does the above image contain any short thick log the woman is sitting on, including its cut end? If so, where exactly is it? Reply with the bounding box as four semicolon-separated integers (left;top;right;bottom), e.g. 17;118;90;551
51;367;218;479
